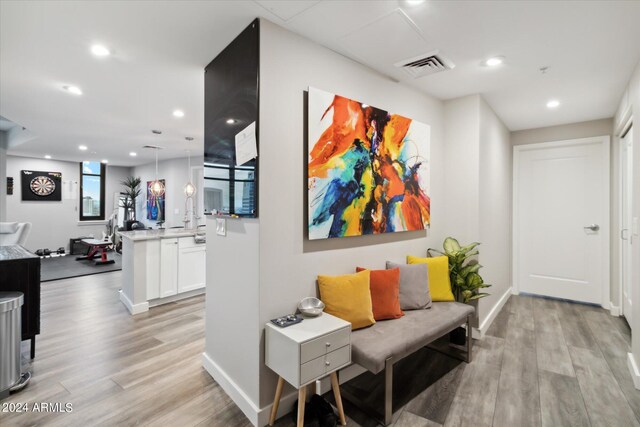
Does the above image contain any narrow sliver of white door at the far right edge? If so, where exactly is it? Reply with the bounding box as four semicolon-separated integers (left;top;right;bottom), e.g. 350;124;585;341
620;129;633;325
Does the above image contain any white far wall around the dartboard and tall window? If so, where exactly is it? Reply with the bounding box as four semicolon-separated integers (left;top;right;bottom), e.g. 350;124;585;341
6;156;129;251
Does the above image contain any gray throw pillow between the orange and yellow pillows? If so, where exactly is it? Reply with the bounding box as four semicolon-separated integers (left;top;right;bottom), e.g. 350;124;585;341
387;261;432;310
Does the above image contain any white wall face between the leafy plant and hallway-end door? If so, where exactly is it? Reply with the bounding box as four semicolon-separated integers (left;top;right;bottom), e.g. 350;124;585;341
478;98;513;330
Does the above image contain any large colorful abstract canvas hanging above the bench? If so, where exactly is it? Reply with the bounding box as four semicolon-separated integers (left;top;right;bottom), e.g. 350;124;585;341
308;88;431;240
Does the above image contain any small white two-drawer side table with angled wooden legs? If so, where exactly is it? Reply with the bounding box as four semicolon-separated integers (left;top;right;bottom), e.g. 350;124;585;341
265;313;351;427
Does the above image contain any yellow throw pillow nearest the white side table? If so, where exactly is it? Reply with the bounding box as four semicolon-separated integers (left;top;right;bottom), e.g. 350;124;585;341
318;270;376;331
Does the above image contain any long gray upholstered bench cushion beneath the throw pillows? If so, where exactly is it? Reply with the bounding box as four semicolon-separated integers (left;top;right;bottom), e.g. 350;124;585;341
351;302;474;374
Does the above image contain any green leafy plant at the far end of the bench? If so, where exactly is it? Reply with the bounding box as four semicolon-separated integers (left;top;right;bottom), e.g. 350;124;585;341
427;237;491;303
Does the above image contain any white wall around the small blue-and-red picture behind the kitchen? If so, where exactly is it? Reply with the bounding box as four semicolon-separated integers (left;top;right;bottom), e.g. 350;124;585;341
131;156;203;228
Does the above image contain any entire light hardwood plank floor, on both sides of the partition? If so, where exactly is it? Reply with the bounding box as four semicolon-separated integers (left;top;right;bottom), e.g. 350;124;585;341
0;272;640;427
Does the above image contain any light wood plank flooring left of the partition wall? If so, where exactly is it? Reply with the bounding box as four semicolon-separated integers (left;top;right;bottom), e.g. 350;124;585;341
0;272;250;427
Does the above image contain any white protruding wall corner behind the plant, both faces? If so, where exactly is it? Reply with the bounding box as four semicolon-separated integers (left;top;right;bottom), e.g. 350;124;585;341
444;95;513;330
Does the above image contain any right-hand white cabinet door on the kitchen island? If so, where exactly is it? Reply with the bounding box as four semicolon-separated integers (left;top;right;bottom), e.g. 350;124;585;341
178;237;207;293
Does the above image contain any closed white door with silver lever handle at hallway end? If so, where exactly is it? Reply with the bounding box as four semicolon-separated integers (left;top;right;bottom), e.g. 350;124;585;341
513;137;609;306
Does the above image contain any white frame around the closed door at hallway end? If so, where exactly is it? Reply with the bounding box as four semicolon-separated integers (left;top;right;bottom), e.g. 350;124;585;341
511;135;611;310
